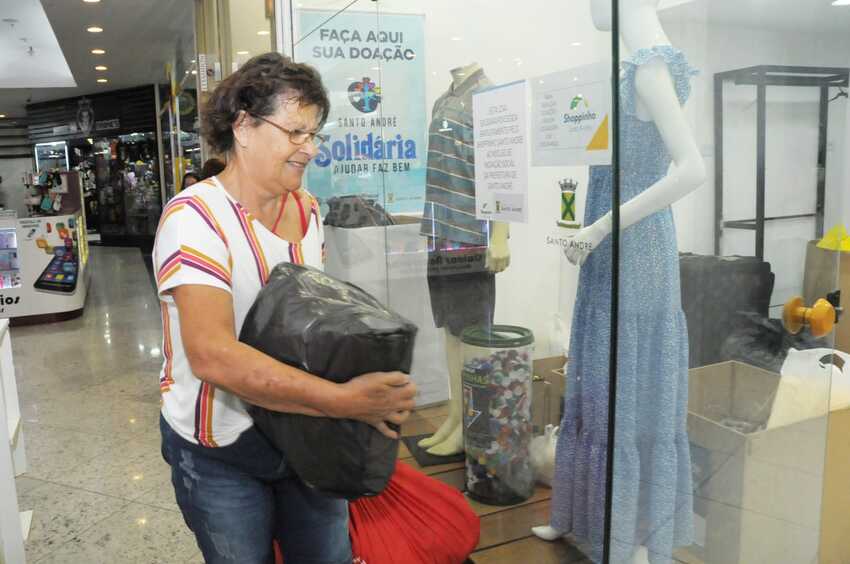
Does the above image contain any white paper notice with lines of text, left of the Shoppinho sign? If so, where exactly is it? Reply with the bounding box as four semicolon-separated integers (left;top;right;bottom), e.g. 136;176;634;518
472;81;528;223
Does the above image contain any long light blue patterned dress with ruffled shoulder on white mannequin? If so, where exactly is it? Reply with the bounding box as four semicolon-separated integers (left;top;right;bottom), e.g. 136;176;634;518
551;46;696;564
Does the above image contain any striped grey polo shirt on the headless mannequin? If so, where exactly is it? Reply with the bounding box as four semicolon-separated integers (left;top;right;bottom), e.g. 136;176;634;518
422;69;490;246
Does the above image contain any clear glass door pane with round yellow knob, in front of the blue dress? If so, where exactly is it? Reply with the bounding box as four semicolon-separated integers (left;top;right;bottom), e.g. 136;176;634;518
611;0;850;564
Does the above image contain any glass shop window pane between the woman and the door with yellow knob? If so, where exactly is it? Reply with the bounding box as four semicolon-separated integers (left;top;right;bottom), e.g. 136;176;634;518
293;1;612;562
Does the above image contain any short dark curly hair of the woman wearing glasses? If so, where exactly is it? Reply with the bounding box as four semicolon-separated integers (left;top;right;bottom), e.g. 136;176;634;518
201;53;331;154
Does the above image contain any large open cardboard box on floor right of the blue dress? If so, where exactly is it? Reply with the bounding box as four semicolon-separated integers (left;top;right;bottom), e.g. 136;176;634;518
688;362;850;564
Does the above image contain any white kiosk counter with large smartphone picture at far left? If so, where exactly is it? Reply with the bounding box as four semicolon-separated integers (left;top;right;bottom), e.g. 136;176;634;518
0;212;88;325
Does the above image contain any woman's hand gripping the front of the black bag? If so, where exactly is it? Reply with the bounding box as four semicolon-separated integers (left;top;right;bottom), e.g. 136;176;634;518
339;372;416;439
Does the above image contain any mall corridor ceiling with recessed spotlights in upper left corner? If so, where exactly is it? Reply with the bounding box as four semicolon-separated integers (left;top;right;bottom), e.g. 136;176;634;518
0;0;194;119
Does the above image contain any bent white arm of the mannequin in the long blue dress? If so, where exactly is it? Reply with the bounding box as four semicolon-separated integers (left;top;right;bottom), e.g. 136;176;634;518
566;60;705;264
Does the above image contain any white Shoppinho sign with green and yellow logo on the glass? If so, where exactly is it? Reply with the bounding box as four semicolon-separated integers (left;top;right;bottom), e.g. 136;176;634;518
531;63;611;166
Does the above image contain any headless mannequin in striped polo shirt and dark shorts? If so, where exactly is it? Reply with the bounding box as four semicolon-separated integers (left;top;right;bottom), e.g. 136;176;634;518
419;62;510;456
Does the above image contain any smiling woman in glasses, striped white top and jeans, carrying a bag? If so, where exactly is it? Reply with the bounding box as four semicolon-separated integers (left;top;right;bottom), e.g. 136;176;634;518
154;53;416;564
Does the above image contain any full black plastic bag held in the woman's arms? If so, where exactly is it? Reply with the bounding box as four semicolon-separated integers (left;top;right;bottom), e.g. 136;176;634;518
239;263;416;500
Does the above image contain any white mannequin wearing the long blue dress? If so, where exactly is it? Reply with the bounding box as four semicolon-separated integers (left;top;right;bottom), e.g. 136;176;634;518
532;0;705;564
